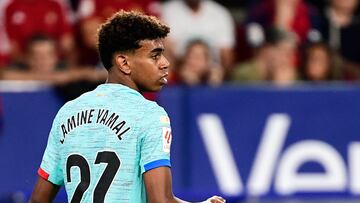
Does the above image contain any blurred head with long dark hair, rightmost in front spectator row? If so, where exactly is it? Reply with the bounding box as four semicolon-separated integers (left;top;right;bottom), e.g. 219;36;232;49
301;42;338;82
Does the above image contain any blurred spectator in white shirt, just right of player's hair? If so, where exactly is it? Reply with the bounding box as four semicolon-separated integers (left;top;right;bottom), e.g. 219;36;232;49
162;0;235;78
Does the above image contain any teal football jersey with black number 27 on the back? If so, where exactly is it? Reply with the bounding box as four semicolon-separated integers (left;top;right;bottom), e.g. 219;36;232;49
38;84;171;203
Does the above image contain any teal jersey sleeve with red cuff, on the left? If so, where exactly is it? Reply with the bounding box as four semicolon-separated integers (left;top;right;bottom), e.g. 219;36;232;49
38;111;64;185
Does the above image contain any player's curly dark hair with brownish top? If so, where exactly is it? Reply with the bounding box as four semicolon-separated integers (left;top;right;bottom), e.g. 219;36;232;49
97;10;170;70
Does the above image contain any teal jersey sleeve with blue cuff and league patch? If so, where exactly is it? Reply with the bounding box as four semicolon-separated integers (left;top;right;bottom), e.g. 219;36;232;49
140;106;172;173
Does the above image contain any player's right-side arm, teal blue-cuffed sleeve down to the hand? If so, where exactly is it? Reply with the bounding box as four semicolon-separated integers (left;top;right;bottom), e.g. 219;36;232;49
140;106;225;203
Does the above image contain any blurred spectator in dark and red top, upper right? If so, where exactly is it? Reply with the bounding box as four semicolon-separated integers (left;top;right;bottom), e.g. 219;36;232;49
247;0;319;46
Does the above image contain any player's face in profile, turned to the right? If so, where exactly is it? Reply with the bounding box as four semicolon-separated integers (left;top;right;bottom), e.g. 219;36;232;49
128;39;169;92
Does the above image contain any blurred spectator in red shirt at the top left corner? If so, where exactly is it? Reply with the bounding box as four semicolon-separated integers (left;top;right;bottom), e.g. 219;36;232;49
5;0;74;64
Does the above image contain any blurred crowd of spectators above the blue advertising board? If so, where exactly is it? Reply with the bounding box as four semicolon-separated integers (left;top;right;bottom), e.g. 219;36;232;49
0;0;360;101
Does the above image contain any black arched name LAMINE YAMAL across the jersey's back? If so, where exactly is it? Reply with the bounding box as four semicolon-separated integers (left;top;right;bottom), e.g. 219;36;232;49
60;109;130;144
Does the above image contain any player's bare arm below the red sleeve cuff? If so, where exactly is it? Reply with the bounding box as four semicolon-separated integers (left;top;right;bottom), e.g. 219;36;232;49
29;177;60;203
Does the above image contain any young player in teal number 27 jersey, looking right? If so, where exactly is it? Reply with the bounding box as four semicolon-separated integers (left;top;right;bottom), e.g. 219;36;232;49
30;11;225;203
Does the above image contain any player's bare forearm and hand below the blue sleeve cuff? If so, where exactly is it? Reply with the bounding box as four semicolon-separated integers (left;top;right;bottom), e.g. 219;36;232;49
143;166;225;203
